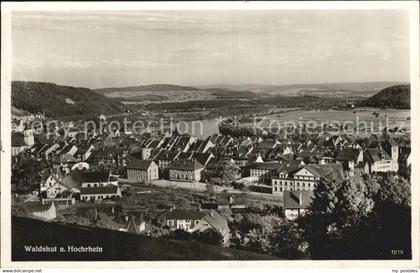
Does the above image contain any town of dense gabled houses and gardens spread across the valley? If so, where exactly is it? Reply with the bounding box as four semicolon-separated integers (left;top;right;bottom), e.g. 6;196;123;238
12;108;411;259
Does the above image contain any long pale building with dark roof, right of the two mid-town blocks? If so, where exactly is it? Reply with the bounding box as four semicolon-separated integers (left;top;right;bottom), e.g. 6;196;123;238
168;159;204;182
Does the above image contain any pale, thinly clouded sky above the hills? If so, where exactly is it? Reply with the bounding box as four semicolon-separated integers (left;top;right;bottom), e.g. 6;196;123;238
12;10;409;88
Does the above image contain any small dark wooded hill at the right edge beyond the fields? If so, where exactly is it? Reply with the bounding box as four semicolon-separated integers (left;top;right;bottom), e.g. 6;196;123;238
360;84;410;109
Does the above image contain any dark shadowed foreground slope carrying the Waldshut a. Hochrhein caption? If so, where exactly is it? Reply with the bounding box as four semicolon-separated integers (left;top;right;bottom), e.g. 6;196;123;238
12;216;280;261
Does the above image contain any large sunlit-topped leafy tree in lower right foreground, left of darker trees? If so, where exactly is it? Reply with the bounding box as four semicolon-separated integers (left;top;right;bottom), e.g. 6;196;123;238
304;175;374;259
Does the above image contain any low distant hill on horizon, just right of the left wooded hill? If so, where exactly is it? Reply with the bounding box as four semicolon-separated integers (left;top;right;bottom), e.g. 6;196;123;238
94;84;200;93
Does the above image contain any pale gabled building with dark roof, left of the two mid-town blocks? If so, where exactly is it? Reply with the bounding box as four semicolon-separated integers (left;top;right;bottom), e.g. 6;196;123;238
127;159;159;182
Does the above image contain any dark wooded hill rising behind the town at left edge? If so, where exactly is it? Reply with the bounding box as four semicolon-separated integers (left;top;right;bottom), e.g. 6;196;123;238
12;81;124;117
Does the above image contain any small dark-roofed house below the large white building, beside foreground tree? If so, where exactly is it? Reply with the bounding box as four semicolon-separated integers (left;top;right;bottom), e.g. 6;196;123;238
283;190;313;221
